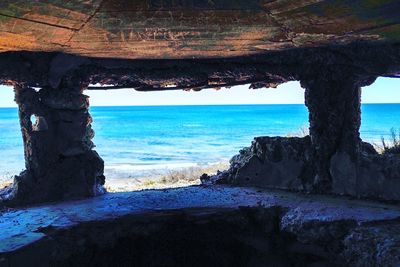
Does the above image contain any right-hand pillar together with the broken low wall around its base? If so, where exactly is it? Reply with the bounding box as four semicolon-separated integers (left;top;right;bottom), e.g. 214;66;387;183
219;70;400;200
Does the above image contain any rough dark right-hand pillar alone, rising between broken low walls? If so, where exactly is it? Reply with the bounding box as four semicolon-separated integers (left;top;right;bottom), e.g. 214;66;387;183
301;72;372;192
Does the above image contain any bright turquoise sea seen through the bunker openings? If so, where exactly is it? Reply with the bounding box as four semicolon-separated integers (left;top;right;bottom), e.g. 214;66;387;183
0;104;400;179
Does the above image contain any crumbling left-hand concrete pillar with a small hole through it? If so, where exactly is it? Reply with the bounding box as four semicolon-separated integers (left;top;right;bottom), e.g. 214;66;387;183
12;86;105;204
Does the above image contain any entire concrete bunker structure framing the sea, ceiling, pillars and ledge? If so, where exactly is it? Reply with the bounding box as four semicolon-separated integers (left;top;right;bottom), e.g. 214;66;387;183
0;0;400;266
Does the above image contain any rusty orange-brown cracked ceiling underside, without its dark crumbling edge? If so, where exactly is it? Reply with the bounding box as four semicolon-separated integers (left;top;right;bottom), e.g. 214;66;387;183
0;0;400;59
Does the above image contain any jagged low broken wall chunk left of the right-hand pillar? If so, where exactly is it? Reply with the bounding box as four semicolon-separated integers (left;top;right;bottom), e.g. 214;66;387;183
220;137;315;190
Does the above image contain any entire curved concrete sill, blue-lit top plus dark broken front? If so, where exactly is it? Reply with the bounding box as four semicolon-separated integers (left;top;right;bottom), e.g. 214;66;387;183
0;186;400;267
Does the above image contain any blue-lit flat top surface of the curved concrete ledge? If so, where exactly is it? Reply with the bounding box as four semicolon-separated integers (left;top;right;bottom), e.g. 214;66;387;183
0;186;400;255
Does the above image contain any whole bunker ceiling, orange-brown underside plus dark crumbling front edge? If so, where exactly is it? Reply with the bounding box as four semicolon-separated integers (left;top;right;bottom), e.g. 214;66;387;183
0;0;400;91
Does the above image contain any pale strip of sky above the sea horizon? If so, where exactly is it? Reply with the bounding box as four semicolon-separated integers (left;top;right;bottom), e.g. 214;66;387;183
0;78;400;107
